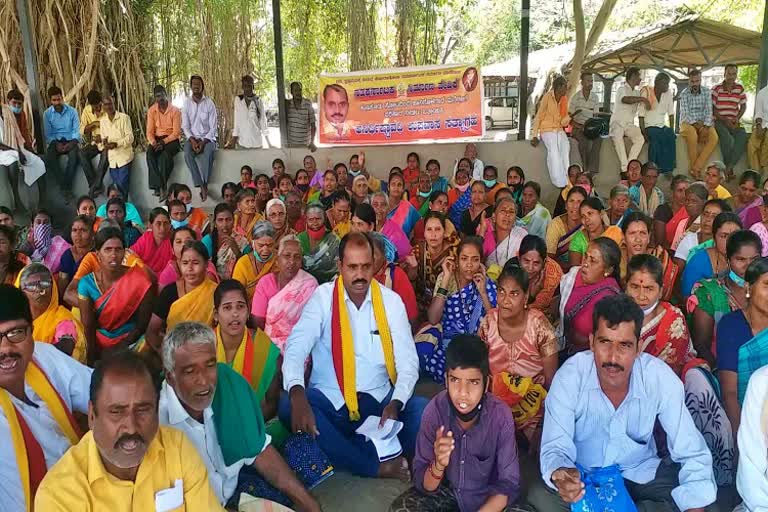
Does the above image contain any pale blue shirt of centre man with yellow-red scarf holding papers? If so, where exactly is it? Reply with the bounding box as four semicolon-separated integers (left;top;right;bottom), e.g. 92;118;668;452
283;279;419;411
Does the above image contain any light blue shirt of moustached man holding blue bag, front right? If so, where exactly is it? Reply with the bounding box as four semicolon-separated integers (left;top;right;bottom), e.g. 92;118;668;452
541;351;717;510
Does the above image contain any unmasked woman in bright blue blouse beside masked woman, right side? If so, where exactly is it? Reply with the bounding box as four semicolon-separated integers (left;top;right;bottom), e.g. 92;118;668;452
680;212;740;297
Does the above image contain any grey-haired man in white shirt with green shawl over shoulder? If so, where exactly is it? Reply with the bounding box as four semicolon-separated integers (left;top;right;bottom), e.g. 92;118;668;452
159;322;320;512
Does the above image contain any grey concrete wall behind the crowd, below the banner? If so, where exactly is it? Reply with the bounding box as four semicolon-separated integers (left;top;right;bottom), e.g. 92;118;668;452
0;137;746;225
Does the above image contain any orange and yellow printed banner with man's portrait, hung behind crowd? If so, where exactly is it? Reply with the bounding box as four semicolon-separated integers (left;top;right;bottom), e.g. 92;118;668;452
318;65;483;145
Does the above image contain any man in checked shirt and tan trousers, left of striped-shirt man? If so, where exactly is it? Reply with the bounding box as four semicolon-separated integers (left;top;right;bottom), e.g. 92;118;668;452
678;69;718;179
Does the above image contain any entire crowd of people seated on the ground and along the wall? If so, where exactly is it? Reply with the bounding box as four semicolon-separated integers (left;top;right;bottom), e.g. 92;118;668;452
0;67;768;512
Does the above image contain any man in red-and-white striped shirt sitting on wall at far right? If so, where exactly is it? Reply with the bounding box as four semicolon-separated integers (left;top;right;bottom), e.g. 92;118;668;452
712;64;747;179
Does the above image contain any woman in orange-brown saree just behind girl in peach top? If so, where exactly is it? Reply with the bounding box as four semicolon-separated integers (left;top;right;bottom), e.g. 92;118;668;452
520;235;563;320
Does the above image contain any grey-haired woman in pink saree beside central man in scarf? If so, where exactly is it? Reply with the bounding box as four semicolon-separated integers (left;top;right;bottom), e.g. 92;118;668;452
251;235;317;351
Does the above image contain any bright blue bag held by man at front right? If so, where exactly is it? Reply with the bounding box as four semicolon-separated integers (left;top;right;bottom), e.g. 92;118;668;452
571;464;637;512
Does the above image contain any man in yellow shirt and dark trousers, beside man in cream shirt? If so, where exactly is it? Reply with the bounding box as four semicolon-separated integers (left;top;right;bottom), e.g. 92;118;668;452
80;91;108;196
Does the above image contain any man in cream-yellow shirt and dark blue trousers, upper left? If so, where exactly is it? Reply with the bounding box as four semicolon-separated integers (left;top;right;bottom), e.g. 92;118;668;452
97;96;133;201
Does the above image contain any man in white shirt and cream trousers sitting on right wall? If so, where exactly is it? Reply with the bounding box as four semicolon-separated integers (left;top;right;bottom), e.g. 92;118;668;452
608;67;651;176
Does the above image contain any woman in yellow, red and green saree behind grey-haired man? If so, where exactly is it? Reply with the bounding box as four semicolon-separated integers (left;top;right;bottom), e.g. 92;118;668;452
213;279;282;422
